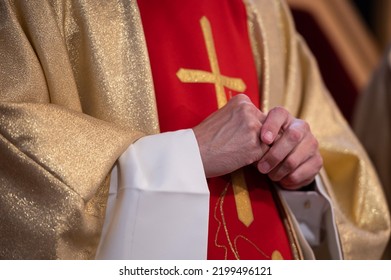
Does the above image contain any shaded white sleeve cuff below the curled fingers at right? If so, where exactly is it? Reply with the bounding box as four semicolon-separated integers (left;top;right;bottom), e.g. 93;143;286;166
280;176;342;259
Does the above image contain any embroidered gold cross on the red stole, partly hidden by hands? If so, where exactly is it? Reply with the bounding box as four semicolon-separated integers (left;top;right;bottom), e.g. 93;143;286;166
176;16;254;227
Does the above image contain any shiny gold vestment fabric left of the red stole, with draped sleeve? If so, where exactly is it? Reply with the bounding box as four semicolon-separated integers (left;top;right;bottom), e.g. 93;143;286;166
0;1;158;259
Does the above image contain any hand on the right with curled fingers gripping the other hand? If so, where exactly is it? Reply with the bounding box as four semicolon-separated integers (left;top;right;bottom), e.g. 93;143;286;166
257;107;323;189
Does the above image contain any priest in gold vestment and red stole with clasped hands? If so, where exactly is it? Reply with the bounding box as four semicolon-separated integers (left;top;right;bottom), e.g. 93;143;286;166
0;0;390;259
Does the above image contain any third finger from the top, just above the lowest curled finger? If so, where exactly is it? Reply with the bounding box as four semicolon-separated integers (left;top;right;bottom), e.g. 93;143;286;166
268;135;318;182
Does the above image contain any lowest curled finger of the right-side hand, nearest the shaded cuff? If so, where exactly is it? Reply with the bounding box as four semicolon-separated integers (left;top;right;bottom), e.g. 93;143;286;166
279;154;323;190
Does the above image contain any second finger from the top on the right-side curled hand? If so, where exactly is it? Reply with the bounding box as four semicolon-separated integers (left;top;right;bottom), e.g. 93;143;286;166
258;120;309;174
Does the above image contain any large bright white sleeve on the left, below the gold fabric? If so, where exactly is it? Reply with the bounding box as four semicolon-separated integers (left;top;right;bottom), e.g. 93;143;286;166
96;129;209;259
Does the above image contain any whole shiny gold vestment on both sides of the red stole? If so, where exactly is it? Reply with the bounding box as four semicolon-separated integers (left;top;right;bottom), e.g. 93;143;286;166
0;0;390;259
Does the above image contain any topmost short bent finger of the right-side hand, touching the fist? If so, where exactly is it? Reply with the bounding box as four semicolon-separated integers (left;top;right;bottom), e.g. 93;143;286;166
261;107;292;145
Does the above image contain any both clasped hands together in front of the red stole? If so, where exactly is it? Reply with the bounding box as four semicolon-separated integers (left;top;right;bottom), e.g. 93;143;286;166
193;94;323;189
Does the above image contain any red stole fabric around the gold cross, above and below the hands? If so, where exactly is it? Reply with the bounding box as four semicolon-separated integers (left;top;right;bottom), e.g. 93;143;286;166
138;0;292;259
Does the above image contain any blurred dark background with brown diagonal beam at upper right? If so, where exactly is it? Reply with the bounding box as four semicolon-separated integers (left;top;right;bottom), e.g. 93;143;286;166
287;0;391;123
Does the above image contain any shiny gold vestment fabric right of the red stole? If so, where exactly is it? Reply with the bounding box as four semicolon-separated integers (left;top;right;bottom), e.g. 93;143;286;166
246;0;390;259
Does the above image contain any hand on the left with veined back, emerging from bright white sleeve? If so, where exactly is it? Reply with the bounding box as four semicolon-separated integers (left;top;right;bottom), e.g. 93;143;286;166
193;94;268;178
